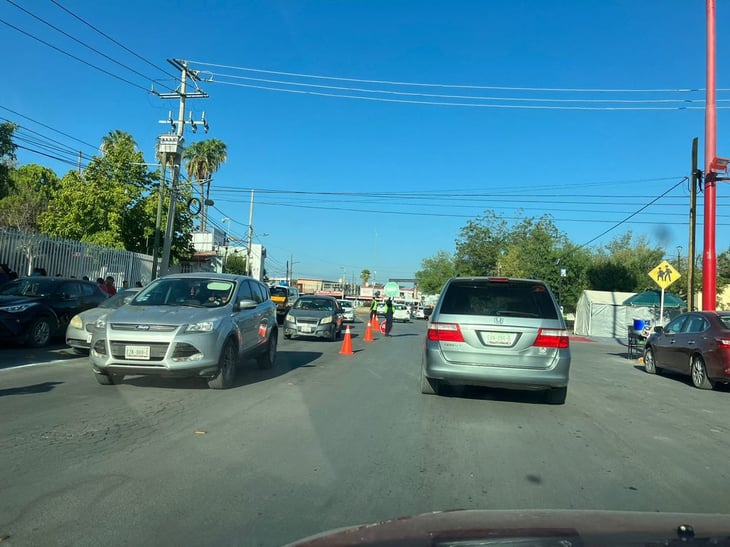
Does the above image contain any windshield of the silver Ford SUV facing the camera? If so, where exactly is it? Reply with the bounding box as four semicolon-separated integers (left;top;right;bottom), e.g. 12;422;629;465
130;277;235;308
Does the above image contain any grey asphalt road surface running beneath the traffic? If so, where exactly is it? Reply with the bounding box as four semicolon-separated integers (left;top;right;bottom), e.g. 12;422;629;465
0;322;730;547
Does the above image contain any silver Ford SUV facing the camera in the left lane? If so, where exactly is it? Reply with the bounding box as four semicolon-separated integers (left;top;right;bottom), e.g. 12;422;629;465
89;272;278;389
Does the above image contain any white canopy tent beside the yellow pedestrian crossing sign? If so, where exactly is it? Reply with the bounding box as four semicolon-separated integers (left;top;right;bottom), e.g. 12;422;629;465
573;291;683;338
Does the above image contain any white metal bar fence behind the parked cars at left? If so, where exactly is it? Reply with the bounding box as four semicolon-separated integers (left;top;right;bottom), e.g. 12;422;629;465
0;228;152;287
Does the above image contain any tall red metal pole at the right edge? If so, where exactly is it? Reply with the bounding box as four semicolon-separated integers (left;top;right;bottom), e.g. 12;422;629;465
702;0;717;311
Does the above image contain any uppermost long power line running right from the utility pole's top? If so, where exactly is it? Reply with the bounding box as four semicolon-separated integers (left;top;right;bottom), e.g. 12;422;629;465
186;61;712;93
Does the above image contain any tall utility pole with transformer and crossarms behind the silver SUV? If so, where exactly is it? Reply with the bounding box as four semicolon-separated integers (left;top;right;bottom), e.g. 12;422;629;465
157;59;208;277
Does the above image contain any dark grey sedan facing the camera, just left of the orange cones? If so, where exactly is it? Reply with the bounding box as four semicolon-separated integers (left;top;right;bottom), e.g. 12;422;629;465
284;296;342;341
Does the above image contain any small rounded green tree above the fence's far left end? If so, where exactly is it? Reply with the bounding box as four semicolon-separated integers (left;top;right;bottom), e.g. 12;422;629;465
0;164;59;232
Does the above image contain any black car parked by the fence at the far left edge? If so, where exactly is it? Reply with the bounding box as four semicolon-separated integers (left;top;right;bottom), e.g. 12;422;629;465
0;276;109;347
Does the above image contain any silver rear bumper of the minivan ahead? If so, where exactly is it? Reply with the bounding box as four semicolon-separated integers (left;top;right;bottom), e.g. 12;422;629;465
422;347;570;390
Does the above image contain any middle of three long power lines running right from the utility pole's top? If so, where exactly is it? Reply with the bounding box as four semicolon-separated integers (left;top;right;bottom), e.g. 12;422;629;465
205;72;712;104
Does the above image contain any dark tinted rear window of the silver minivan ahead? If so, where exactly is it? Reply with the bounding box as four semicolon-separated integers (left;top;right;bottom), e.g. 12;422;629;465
441;280;558;319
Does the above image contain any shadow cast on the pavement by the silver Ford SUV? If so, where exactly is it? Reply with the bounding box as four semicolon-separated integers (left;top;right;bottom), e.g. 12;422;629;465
114;351;323;389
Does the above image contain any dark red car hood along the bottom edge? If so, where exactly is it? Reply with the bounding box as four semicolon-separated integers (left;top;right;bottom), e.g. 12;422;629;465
289;510;730;547
